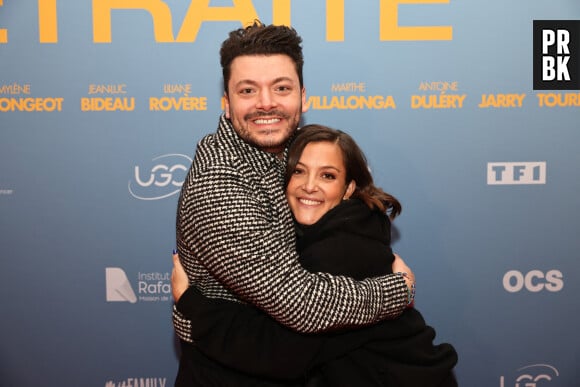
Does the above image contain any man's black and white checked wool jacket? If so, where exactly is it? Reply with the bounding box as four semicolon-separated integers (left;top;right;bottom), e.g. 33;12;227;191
173;115;407;342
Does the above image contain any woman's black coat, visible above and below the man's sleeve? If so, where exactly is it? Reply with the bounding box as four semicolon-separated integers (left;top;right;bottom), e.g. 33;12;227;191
176;199;457;387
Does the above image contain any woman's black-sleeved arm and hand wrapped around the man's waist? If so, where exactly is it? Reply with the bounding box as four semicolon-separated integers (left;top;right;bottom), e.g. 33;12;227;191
171;254;418;380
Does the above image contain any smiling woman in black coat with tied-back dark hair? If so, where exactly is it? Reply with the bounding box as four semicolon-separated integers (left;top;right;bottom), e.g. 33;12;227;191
173;125;457;387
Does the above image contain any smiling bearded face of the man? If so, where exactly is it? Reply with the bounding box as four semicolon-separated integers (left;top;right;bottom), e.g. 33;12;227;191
225;54;307;153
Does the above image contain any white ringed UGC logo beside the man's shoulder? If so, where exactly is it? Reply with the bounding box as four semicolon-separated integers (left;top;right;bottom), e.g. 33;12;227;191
128;154;192;200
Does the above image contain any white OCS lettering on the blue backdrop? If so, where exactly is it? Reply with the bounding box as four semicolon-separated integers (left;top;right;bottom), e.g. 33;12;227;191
503;270;564;293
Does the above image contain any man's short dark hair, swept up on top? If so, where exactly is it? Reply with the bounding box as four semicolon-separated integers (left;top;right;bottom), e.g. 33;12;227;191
220;20;304;93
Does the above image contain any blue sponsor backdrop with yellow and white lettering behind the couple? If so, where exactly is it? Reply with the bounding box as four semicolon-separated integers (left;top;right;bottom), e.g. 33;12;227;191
0;0;580;387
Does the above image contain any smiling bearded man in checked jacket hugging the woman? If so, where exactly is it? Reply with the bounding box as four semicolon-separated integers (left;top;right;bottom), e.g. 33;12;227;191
174;23;412;386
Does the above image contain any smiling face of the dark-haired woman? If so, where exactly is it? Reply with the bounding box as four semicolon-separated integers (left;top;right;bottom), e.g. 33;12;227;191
286;142;355;225
